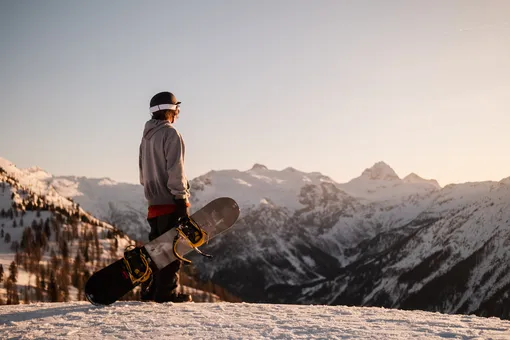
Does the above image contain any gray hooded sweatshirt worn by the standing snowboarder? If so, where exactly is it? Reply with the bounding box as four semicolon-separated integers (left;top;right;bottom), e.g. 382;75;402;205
139;119;190;205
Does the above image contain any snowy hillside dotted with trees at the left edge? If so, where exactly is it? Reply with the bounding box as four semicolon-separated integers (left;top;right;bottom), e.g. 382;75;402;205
0;162;133;303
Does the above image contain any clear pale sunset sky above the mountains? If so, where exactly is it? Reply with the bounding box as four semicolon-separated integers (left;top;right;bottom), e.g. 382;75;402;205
0;0;510;185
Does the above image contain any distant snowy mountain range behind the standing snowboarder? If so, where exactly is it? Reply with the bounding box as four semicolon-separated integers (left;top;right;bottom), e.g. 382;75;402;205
0;157;510;318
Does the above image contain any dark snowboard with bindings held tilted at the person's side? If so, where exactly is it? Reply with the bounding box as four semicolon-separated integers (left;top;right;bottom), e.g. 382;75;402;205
85;197;240;305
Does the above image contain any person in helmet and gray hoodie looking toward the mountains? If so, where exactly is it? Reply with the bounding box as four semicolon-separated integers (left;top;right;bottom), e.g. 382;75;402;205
139;92;191;302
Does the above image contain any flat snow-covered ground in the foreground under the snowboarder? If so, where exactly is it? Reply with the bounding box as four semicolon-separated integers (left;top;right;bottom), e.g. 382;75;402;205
0;302;510;340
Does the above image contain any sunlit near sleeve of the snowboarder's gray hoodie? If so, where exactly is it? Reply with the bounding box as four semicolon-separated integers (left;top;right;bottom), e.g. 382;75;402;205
164;129;189;199
